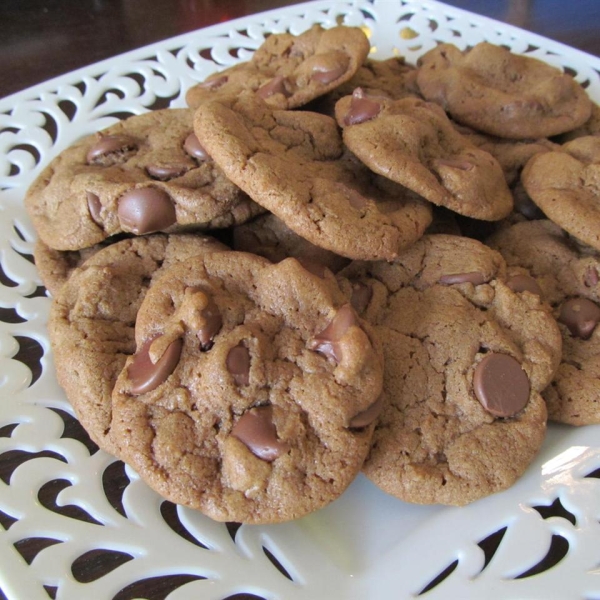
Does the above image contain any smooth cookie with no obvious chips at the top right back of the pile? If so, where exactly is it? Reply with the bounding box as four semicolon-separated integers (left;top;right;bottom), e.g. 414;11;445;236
417;42;592;139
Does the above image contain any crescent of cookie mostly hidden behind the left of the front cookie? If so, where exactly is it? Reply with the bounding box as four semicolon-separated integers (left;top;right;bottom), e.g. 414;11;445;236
48;234;226;454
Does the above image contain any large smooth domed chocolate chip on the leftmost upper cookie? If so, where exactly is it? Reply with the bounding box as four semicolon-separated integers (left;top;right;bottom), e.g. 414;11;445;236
117;187;176;235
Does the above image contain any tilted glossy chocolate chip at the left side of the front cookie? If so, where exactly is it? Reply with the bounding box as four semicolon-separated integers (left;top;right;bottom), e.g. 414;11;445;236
127;336;183;396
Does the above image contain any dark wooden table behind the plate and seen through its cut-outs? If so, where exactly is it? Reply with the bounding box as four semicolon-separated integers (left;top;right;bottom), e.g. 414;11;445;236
0;0;600;600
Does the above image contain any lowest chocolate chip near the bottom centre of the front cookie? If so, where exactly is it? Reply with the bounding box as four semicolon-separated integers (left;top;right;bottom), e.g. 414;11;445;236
231;406;289;462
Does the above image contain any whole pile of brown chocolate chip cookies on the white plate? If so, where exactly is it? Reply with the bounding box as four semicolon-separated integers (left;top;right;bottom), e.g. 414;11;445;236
25;26;600;523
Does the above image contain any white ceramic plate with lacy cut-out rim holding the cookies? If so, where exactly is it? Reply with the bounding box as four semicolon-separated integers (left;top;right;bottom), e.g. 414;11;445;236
0;0;600;600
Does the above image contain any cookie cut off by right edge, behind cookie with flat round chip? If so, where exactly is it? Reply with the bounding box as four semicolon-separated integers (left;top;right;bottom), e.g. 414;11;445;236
488;220;600;425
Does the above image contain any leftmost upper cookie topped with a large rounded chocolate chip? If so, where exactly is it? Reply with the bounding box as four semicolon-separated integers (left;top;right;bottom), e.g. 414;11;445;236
25;109;263;250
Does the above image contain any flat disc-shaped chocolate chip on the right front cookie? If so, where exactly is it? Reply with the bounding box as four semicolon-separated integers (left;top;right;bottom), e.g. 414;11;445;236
473;352;531;417
